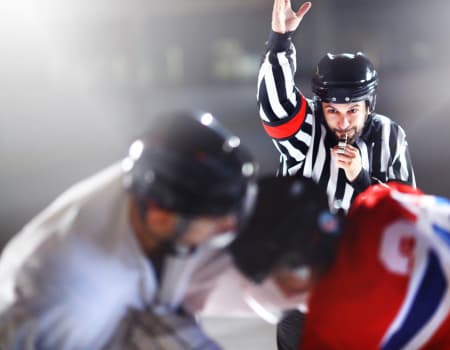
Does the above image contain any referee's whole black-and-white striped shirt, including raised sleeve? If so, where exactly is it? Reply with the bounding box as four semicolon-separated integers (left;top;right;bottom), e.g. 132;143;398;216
257;33;415;210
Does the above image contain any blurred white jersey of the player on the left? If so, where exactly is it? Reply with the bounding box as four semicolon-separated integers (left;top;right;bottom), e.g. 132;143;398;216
0;164;306;350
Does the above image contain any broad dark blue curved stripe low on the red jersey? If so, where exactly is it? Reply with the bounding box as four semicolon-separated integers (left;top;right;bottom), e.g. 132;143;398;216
382;252;447;350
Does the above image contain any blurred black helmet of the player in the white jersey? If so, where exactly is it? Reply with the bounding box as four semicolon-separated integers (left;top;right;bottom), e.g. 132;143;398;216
123;111;256;217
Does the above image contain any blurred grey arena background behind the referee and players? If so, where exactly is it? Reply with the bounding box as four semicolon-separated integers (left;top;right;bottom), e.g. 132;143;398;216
0;0;450;247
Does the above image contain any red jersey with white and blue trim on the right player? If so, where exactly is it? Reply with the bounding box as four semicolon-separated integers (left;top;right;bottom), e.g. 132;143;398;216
301;184;450;350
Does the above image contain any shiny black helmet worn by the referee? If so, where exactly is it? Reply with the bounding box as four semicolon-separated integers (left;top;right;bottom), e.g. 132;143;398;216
312;52;378;111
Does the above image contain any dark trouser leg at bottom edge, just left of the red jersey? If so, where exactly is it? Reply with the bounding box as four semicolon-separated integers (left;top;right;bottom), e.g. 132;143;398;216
277;310;305;350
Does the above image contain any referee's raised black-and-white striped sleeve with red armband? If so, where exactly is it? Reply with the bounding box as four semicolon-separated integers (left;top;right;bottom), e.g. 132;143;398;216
257;32;314;175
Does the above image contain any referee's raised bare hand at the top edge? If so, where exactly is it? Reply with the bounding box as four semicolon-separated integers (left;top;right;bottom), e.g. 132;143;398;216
272;0;312;34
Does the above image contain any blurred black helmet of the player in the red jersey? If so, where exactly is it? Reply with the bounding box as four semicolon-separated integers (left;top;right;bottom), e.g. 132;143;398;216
230;176;341;283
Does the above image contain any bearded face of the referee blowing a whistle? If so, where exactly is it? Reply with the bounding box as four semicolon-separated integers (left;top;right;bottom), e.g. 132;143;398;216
322;101;368;143
